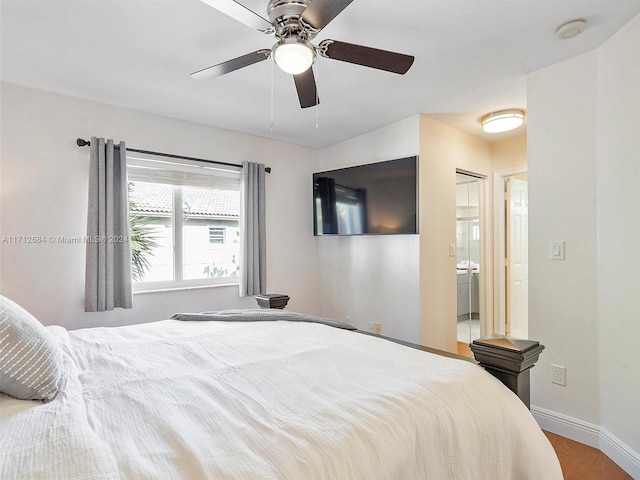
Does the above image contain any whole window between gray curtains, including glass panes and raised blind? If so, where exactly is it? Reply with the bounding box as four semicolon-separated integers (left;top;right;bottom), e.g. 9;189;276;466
127;157;240;290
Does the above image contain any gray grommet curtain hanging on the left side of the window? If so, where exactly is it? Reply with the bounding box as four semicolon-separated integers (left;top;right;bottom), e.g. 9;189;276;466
84;137;132;312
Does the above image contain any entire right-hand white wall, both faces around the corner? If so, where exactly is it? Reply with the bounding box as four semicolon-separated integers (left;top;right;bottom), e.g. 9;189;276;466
528;13;640;475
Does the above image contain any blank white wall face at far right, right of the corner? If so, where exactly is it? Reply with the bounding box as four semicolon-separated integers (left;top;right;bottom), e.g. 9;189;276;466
596;16;640;464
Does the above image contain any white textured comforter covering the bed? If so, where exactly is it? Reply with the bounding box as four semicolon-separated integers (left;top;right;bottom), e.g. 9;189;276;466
0;320;562;480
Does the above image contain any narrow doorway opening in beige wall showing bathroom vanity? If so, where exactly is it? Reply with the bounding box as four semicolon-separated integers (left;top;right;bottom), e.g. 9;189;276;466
456;172;482;345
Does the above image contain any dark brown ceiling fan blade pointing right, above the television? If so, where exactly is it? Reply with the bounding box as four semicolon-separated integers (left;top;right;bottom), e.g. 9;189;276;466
312;39;414;75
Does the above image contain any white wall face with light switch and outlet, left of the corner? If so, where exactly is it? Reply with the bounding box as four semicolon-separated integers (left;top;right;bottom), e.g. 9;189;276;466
528;47;600;424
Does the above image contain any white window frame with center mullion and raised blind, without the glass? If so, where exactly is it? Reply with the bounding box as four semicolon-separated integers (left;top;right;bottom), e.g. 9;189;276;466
127;154;241;293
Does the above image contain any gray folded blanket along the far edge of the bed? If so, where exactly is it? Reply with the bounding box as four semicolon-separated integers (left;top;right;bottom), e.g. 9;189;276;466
171;309;357;330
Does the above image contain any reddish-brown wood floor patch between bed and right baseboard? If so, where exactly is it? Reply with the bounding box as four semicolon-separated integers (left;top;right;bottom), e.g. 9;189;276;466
544;432;633;480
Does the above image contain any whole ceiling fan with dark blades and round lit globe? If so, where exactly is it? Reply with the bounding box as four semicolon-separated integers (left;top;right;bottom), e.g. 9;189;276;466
191;0;414;108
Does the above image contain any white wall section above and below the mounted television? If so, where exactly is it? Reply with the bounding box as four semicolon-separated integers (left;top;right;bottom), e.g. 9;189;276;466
318;116;420;343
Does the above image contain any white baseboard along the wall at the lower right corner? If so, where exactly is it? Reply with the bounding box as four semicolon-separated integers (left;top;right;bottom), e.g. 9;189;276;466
531;406;640;479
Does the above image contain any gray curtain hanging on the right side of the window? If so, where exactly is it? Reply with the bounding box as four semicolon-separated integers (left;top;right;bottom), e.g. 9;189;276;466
240;162;267;297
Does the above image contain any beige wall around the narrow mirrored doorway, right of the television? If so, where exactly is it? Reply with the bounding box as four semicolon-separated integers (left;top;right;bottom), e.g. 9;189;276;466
420;115;493;352
